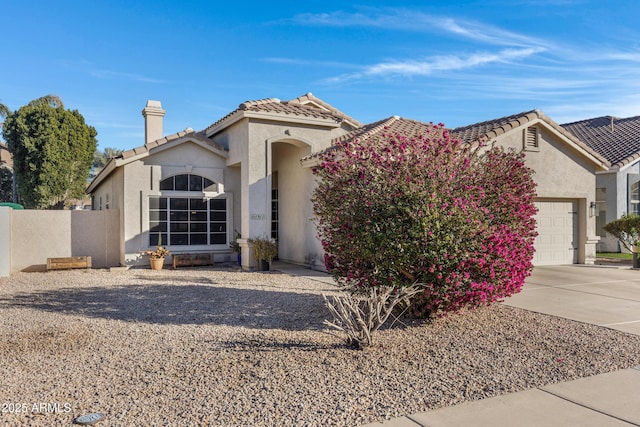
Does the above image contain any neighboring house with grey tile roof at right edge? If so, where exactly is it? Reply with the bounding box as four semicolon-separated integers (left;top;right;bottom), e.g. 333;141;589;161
562;116;640;252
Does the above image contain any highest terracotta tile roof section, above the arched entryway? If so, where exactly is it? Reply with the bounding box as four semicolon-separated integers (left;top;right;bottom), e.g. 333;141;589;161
205;93;362;132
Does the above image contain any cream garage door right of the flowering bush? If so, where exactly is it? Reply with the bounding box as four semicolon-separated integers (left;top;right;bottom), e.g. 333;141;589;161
533;200;578;265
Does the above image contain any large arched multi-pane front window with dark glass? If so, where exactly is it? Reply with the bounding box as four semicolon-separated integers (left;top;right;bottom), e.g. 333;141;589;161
149;174;228;246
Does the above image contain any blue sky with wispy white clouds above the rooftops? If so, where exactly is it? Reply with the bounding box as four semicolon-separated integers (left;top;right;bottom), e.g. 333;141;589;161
0;0;640;149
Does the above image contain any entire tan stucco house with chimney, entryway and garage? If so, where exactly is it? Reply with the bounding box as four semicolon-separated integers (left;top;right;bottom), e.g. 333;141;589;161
88;94;608;269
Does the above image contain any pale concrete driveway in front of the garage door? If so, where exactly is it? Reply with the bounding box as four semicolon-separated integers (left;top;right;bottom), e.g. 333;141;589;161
505;265;640;335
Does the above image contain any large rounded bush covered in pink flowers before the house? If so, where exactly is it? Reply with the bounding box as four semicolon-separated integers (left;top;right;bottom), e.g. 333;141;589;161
312;125;536;316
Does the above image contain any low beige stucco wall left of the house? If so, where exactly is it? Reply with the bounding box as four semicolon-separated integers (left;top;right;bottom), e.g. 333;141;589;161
10;210;120;272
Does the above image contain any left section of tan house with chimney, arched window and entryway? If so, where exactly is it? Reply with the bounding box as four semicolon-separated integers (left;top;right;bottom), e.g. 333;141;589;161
87;94;362;268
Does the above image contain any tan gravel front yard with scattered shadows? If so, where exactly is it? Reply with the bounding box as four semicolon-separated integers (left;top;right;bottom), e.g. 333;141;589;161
0;269;640;426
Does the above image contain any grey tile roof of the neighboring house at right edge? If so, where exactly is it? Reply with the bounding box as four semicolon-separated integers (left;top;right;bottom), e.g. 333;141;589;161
562;116;640;167
